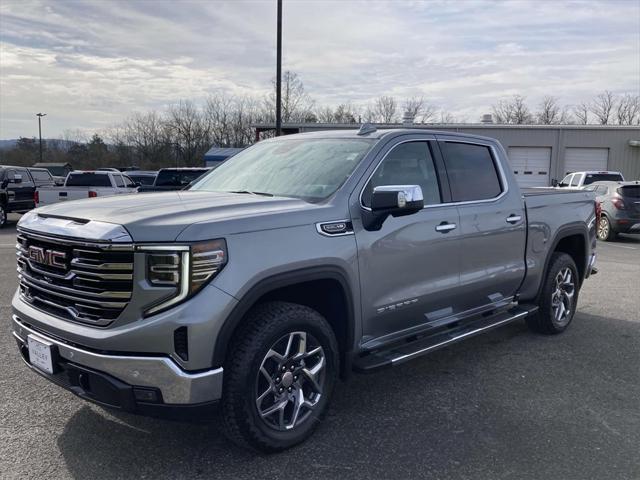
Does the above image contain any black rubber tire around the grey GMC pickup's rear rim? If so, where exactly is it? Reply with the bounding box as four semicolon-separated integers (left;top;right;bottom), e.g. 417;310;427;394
527;252;580;335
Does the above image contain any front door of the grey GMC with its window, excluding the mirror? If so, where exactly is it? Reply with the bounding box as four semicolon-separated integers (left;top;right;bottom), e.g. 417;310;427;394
352;135;459;348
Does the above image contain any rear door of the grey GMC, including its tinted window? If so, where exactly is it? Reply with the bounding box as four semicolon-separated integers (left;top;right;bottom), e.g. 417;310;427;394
438;136;526;314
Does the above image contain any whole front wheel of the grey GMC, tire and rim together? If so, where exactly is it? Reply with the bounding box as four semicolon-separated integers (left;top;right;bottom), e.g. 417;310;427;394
222;302;339;452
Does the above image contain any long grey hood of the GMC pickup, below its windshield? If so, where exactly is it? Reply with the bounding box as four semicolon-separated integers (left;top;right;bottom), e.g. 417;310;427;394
34;191;326;242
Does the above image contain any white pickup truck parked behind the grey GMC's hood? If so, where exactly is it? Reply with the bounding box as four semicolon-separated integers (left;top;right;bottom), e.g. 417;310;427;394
37;170;138;207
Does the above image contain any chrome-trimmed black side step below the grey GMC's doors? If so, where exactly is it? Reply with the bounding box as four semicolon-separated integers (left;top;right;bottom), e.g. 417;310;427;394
353;305;538;373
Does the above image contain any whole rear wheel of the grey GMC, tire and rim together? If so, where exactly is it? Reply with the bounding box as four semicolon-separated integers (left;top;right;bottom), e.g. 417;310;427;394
527;252;579;334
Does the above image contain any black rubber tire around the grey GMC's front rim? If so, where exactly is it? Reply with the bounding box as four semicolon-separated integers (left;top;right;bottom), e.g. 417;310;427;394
222;301;339;453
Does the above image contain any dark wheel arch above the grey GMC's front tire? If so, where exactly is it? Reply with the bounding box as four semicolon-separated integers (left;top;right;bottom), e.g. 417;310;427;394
212;266;356;376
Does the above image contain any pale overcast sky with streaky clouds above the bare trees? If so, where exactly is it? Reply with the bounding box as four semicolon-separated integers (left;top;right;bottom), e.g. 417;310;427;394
0;0;640;139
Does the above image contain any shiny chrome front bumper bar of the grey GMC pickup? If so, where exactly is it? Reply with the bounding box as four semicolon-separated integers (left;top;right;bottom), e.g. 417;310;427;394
13;315;223;404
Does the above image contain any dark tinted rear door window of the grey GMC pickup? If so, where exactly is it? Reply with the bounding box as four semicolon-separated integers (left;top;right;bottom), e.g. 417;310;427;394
440;142;502;202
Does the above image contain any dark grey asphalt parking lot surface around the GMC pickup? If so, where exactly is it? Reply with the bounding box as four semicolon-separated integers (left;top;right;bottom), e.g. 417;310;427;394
0;217;640;479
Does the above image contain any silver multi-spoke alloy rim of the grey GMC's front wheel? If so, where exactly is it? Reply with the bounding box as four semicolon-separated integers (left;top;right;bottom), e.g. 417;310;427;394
255;331;326;431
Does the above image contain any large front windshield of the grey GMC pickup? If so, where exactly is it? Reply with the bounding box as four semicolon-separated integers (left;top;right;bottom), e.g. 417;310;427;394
191;138;374;202
